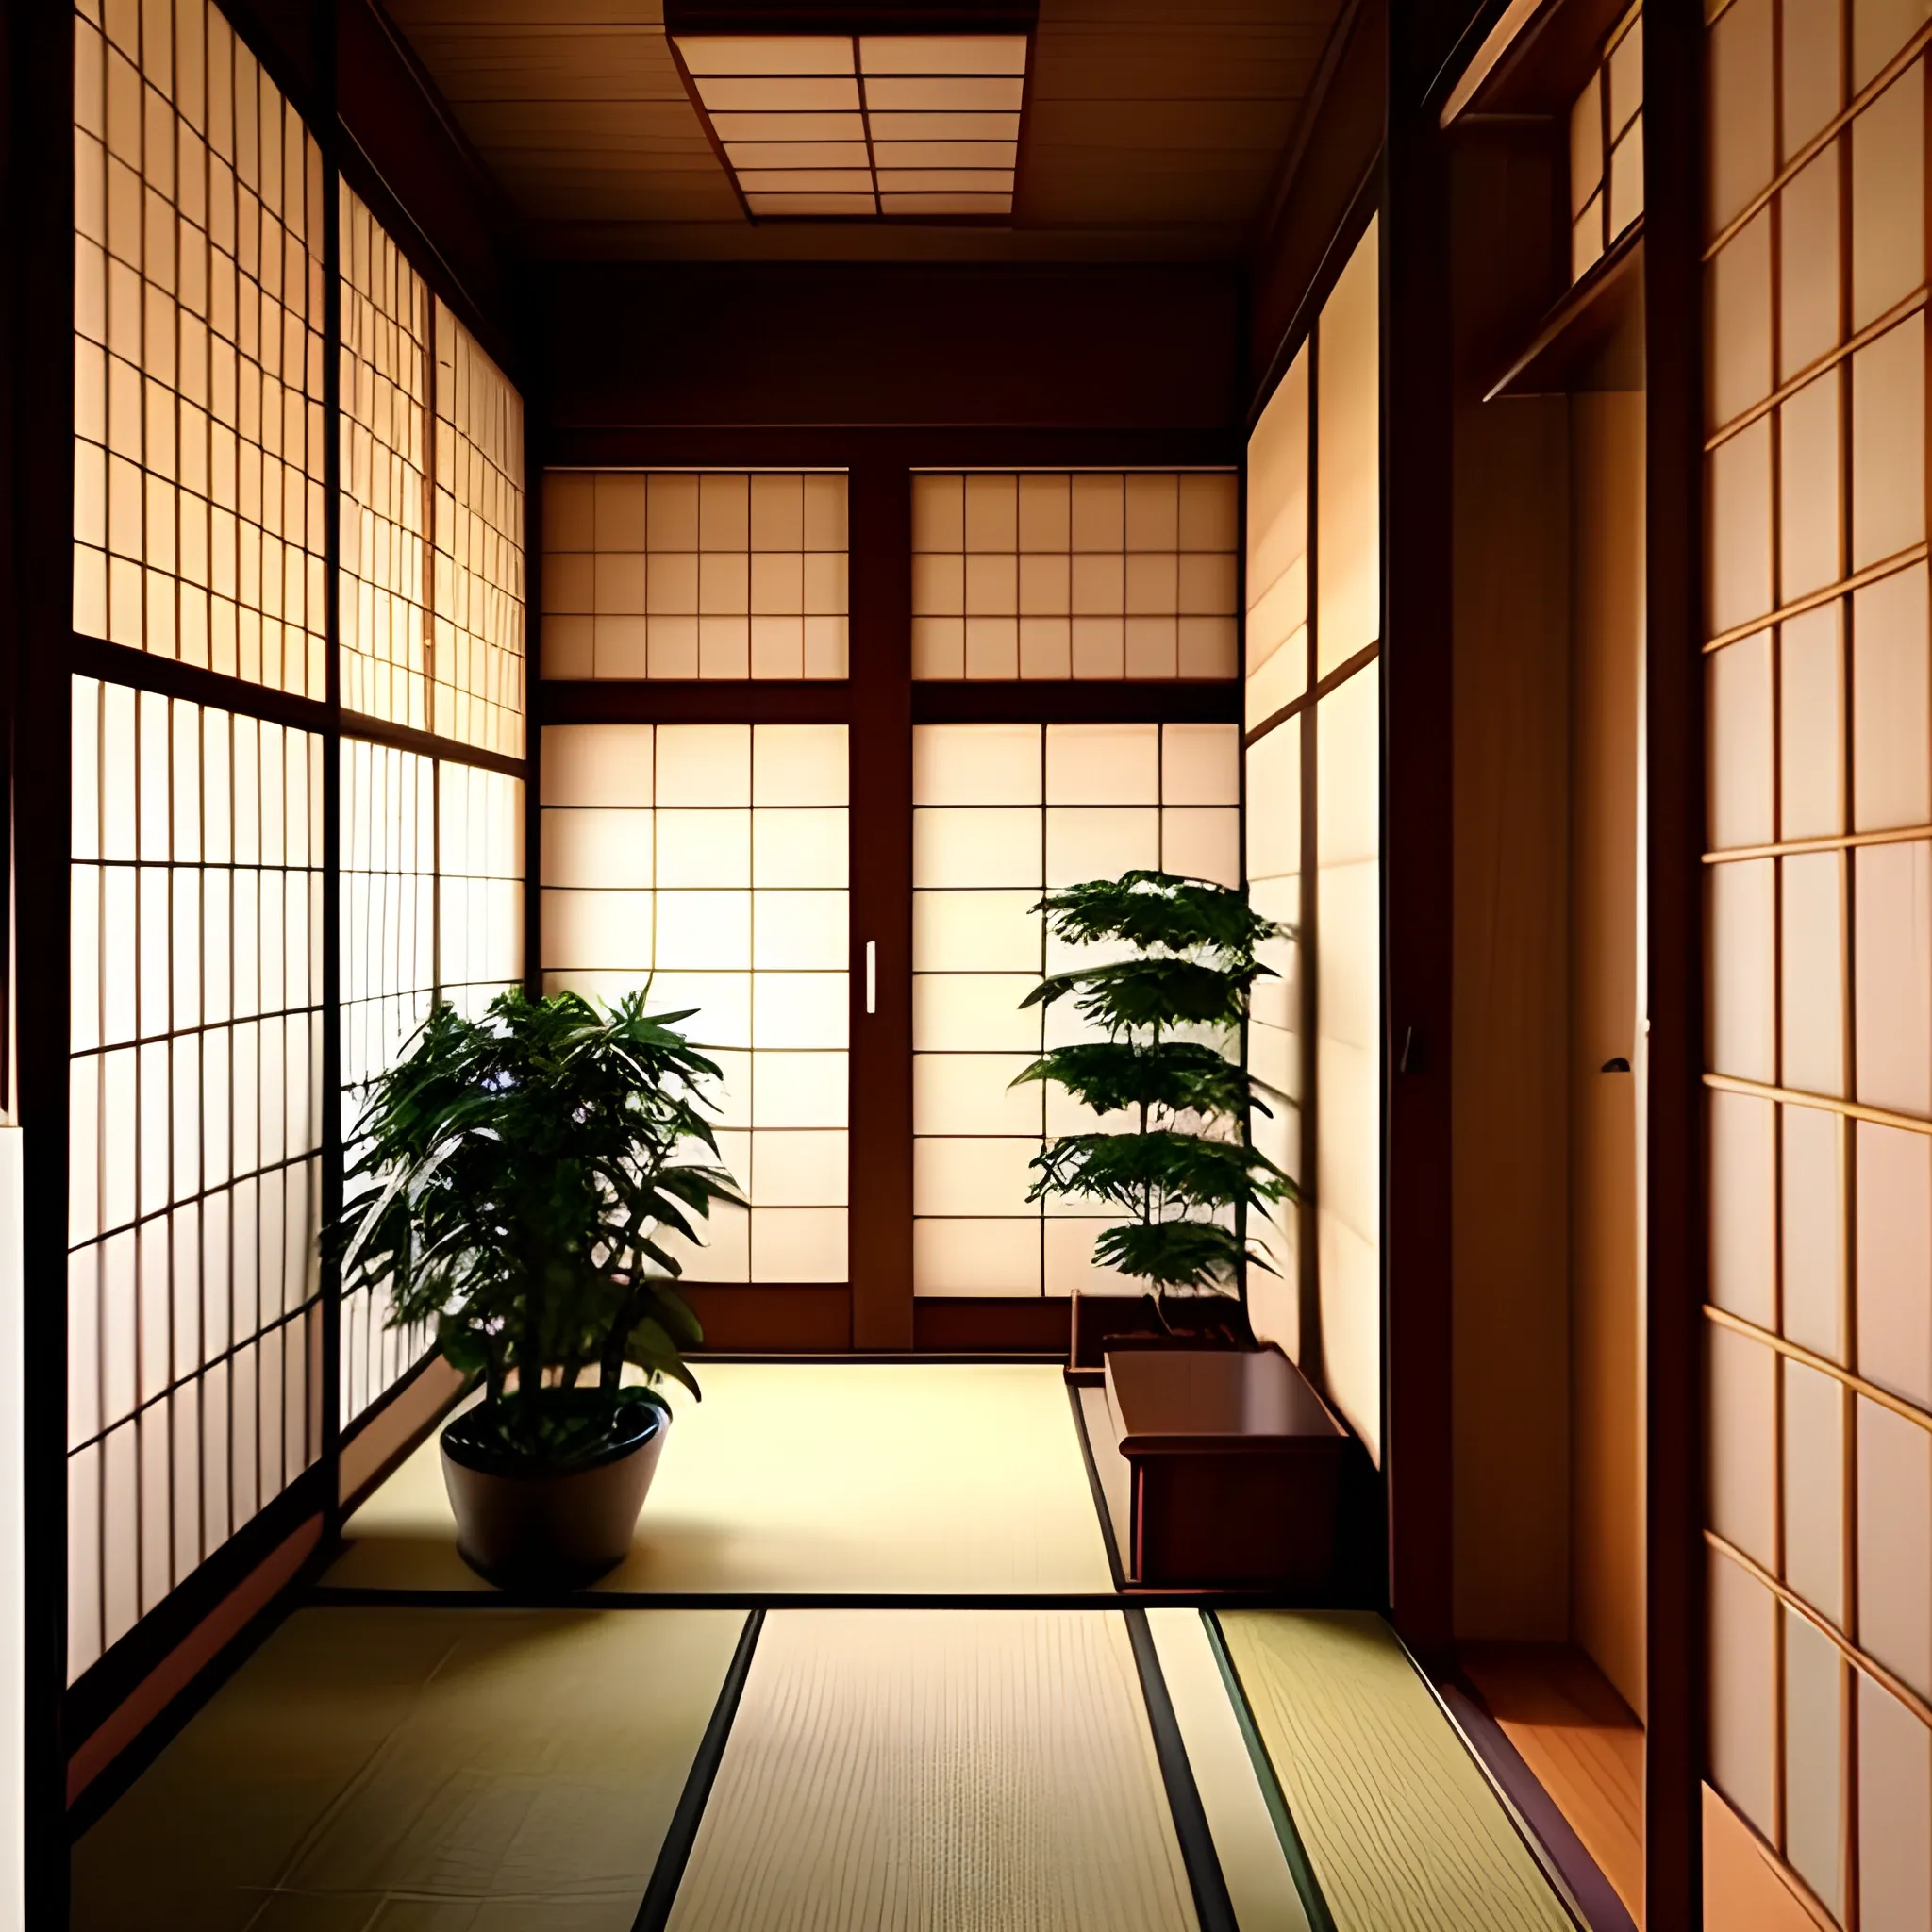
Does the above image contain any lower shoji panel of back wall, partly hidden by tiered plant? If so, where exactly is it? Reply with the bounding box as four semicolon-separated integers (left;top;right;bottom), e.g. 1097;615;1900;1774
912;724;1241;1294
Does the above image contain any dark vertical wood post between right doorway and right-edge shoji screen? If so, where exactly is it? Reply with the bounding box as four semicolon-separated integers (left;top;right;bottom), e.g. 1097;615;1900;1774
1644;6;1706;1926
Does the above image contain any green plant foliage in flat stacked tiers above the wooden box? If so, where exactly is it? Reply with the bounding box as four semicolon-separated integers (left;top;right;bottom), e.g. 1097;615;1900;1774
1014;872;1298;1327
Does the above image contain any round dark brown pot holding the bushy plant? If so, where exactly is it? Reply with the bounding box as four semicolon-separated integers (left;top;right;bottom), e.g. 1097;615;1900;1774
442;1391;671;1591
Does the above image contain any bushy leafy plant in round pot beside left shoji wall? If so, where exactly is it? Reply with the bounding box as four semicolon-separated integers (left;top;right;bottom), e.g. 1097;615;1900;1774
326;990;740;1588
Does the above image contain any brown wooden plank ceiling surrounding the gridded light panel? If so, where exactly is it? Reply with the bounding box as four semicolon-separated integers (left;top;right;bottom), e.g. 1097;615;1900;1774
373;0;1341;260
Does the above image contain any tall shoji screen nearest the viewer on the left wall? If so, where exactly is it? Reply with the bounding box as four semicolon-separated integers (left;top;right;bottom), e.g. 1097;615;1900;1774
68;0;330;1677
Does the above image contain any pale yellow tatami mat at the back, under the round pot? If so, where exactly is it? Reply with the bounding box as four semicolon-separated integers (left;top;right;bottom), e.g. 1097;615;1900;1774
323;1362;1113;1596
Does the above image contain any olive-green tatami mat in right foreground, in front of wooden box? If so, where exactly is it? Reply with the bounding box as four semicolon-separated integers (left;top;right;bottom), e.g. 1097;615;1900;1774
1219;1611;1574;1932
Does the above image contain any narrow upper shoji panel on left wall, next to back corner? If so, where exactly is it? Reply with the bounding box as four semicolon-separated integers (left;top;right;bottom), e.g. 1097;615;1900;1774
431;297;524;758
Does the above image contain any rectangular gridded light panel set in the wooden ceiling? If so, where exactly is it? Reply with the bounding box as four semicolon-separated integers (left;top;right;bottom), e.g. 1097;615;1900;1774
671;33;1030;220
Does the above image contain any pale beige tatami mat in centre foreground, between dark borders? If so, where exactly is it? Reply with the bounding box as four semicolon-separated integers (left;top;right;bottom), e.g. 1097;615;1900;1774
671;1609;1196;1932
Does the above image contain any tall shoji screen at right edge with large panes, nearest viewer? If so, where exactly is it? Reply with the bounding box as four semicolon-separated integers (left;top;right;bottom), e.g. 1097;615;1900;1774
1706;0;1932;1932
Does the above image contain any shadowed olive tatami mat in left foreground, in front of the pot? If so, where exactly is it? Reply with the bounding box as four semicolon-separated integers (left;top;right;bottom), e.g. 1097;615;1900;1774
72;1607;743;1932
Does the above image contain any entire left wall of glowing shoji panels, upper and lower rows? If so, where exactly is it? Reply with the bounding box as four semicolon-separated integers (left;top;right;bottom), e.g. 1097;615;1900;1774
68;0;524;1707
